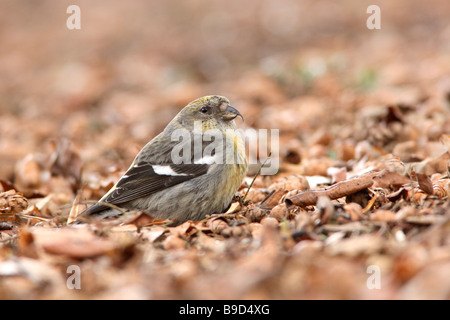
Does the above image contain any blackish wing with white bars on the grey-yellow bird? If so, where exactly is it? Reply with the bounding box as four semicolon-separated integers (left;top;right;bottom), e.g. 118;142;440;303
83;163;209;215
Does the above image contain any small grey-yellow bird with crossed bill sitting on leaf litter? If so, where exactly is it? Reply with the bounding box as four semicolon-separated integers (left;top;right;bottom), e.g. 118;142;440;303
80;95;247;226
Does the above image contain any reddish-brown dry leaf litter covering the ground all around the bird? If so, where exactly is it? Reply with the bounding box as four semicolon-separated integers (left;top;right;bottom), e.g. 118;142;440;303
0;1;450;299
